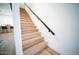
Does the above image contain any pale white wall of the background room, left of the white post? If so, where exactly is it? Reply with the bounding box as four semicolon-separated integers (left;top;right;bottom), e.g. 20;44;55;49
0;3;13;25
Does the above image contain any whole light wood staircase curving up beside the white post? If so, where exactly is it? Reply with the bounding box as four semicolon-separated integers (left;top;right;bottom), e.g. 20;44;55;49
20;8;59;55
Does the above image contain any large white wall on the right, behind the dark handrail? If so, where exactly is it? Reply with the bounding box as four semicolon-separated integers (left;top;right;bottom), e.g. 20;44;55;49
27;3;79;54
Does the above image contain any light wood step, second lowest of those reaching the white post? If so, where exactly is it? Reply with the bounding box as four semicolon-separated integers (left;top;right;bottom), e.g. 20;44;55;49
22;36;43;50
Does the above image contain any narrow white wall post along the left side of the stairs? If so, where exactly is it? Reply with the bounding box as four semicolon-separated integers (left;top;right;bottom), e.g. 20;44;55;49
12;3;23;55
